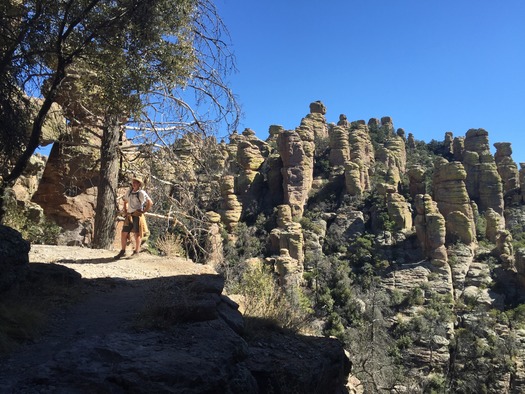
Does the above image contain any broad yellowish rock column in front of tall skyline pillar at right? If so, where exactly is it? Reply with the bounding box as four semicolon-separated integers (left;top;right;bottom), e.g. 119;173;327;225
432;158;476;245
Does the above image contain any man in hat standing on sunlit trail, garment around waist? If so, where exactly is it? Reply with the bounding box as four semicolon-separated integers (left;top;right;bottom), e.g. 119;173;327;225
115;178;153;260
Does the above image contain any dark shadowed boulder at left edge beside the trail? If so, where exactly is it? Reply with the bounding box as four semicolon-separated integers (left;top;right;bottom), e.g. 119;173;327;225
0;225;31;292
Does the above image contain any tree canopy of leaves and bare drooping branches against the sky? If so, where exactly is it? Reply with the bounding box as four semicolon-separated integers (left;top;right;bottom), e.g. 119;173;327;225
0;0;239;222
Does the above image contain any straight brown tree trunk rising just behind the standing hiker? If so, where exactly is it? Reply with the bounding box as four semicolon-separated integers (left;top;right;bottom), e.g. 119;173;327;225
92;115;120;249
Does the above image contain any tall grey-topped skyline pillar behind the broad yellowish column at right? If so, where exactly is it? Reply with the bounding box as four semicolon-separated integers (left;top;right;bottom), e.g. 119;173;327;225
463;129;503;215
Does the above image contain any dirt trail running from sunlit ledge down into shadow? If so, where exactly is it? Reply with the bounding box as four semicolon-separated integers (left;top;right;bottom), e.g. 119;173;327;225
0;245;213;393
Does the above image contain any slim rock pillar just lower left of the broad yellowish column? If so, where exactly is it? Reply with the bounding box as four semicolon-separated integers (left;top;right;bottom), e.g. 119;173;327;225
414;194;447;266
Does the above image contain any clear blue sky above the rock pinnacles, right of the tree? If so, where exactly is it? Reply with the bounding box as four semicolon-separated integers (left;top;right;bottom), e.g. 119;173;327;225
216;0;525;163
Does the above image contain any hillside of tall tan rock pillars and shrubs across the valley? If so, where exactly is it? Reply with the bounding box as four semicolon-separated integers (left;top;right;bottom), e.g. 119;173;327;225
9;102;525;393
